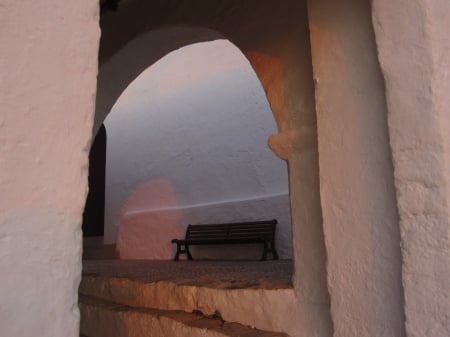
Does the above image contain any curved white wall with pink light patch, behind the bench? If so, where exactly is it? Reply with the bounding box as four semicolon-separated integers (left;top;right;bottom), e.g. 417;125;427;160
105;40;292;259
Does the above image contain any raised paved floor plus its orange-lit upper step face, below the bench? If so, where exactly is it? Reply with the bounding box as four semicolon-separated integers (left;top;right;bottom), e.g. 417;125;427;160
79;260;298;337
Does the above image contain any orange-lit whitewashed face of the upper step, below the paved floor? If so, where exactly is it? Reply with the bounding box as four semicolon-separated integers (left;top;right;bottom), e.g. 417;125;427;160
79;274;302;337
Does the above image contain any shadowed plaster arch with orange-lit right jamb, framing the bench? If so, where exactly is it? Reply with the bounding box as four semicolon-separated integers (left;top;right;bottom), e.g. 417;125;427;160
97;0;332;336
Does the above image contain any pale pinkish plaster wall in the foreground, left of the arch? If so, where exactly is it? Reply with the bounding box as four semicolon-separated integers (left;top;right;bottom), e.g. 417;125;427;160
0;0;99;337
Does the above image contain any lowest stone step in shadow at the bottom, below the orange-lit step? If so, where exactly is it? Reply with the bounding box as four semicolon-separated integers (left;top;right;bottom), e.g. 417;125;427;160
79;296;288;337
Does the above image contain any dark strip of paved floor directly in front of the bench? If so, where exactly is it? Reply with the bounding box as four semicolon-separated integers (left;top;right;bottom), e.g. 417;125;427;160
83;260;293;289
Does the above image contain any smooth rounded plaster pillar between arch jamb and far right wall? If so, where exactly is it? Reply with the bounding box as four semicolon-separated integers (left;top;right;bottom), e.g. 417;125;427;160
309;0;405;337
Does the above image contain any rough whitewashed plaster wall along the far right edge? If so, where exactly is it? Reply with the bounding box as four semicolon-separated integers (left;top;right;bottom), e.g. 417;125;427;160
373;0;450;337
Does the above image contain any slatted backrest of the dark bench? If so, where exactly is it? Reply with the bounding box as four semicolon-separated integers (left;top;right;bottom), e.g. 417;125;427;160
186;219;277;240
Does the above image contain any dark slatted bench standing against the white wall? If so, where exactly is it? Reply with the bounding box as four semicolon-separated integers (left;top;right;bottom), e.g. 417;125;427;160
172;219;278;261
